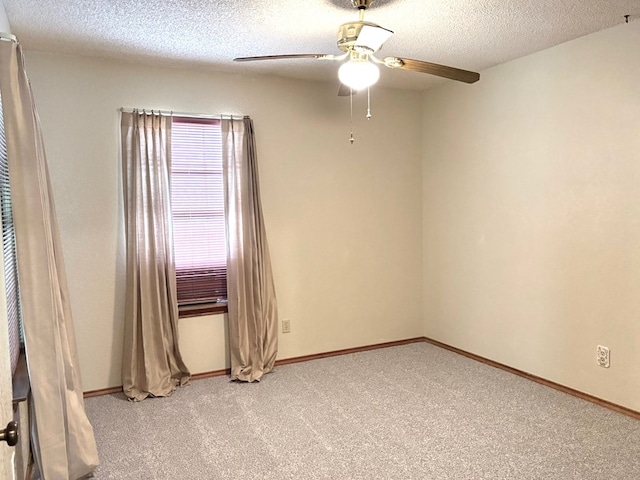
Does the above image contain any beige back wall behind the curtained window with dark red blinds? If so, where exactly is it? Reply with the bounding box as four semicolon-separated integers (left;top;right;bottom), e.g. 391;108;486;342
26;52;423;390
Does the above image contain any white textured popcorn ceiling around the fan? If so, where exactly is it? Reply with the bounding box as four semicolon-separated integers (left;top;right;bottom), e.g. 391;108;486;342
2;0;640;89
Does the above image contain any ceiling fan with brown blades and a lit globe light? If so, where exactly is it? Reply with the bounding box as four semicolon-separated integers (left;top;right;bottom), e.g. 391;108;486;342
233;0;480;95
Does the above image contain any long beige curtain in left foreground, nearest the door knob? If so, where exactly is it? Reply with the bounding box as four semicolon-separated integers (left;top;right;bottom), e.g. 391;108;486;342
0;41;98;480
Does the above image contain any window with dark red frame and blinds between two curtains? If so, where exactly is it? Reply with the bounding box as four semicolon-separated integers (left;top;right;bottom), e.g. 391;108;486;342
171;117;227;316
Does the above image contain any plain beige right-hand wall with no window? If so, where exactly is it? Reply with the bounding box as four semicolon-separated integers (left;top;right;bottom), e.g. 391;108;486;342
423;22;640;410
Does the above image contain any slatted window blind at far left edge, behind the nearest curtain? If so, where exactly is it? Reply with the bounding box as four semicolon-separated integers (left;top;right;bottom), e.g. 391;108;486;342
0;89;22;373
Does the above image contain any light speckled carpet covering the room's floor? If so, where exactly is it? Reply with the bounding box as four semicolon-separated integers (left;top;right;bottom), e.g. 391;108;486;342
86;343;640;480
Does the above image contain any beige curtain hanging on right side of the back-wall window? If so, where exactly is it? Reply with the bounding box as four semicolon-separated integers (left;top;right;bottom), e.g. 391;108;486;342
222;117;278;382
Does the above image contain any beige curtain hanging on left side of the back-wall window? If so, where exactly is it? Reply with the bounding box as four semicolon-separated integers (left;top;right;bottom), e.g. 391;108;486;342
121;111;190;401
